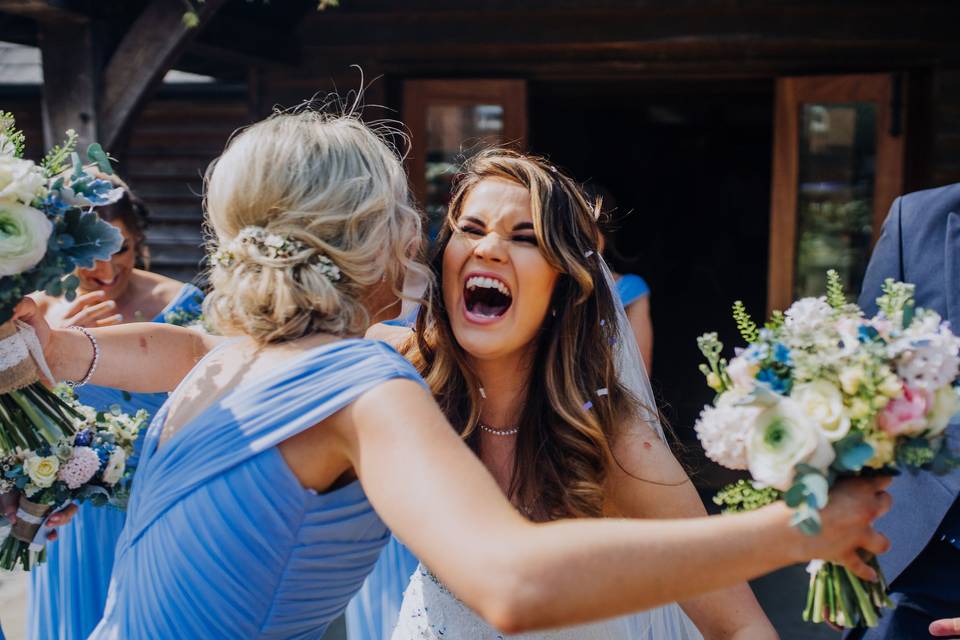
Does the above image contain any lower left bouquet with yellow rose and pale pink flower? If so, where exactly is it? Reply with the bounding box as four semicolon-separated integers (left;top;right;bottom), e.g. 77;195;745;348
0;387;148;570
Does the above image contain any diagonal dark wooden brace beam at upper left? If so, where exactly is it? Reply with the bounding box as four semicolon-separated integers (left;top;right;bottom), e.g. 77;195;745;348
99;0;226;148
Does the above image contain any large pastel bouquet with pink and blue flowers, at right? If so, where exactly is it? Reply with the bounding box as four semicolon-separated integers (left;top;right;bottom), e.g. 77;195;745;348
696;271;960;627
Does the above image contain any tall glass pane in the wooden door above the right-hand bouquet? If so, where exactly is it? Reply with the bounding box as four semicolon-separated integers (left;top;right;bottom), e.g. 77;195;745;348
794;102;877;297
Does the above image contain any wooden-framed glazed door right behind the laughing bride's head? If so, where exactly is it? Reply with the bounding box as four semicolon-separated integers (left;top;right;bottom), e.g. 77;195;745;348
403;80;527;238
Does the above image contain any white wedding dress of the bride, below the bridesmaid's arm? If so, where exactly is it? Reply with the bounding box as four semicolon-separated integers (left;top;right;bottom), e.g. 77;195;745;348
391;565;703;640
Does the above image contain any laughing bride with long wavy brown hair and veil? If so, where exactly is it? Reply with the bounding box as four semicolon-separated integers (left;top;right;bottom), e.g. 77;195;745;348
367;149;777;640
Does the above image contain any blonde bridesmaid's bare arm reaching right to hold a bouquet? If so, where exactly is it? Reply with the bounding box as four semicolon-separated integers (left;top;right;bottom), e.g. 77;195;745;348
337;380;889;632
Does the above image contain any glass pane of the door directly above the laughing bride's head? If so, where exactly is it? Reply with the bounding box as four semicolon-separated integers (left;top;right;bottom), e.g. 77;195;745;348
424;104;504;238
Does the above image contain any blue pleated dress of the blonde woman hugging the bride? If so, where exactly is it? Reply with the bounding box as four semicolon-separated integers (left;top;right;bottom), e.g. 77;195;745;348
91;339;423;640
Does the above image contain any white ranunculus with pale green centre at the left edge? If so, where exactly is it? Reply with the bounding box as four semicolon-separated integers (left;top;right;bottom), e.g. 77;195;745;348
0;200;53;276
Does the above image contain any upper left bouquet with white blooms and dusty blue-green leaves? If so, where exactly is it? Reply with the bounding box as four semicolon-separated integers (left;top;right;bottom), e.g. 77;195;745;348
0;112;123;453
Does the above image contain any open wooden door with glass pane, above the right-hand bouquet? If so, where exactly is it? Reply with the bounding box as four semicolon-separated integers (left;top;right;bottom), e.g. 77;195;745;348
767;74;905;310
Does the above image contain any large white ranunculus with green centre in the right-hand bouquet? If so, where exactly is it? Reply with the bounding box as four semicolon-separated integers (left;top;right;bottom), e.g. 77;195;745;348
747;398;836;491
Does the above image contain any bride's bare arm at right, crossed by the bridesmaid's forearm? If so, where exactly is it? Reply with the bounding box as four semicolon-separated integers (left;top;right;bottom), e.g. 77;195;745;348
607;425;779;640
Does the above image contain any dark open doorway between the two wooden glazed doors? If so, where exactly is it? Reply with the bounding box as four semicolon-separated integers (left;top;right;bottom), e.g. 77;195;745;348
529;80;773;480
